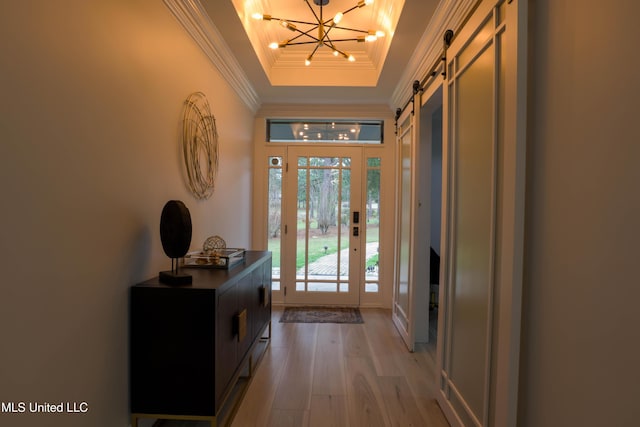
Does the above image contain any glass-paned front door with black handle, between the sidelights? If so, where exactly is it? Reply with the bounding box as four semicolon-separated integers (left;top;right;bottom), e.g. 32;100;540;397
281;146;362;305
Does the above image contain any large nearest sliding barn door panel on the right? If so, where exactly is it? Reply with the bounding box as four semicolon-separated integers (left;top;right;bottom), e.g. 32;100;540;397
438;0;526;426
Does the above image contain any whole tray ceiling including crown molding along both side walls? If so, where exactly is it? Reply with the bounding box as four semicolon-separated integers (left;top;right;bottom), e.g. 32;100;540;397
195;0;442;108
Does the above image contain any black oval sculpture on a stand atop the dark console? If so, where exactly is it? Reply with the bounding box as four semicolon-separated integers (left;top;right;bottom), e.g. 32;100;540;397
160;200;192;285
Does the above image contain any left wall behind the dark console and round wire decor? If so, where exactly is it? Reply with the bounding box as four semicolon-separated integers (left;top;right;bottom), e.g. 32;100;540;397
0;0;253;427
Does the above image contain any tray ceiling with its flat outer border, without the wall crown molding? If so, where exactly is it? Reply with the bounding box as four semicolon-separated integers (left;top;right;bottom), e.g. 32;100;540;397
202;0;440;107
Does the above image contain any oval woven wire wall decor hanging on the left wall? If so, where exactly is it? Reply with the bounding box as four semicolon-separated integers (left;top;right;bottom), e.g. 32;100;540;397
182;92;218;200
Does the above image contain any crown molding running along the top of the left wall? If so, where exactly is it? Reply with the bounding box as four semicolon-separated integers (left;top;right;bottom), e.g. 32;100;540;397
163;0;260;113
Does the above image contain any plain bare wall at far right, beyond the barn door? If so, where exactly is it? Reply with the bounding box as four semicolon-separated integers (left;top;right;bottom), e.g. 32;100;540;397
519;0;640;427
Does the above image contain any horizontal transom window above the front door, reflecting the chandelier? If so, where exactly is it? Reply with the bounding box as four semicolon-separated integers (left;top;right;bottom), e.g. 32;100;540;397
267;119;383;144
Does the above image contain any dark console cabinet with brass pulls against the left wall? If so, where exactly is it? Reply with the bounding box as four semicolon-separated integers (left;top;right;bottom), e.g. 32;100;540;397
130;251;271;427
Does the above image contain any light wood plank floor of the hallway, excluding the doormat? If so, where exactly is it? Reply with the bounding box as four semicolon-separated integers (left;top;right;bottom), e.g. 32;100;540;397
232;307;448;427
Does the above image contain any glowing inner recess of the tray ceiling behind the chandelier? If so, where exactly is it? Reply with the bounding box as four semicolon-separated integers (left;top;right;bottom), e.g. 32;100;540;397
233;0;404;86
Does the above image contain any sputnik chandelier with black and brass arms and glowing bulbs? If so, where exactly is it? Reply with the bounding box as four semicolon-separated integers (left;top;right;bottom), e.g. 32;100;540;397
253;0;384;66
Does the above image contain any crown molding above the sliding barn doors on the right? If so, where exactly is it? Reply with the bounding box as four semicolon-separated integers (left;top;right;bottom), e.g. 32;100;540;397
390;0;479;109
